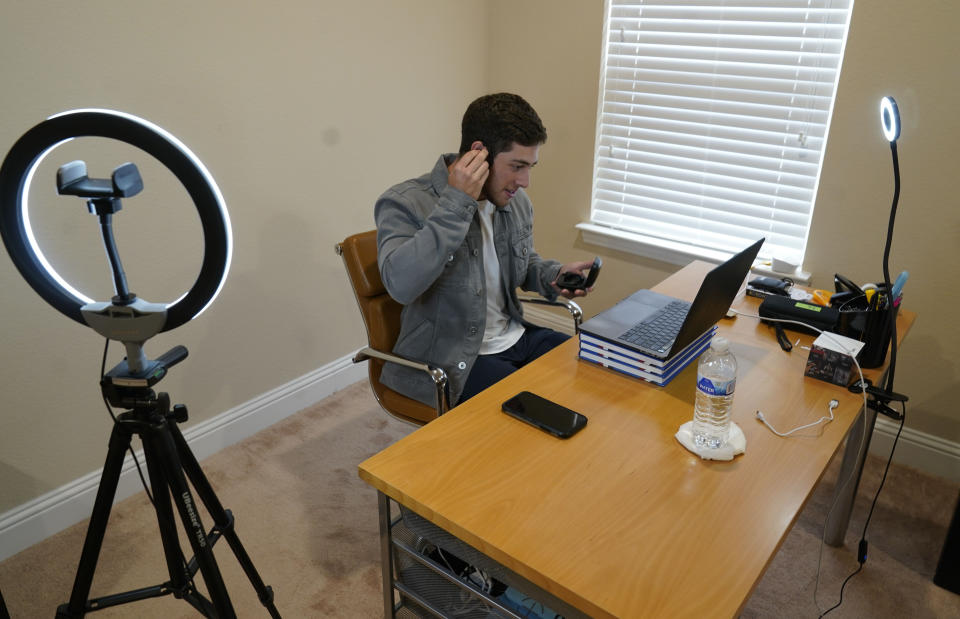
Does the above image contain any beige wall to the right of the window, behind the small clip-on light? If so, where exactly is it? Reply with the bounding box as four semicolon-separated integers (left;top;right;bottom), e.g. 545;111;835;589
808;0;960;442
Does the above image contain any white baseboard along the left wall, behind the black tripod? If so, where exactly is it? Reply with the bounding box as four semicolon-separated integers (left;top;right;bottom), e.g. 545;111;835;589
0;355;367;561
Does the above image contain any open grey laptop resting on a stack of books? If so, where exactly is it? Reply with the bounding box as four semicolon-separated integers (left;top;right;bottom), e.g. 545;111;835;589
580;239;765;360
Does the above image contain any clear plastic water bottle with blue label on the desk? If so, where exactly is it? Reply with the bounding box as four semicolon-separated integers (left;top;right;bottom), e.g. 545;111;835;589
693;337;737;449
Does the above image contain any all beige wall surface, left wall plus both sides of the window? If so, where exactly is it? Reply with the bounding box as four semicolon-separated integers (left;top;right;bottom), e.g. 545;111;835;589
0;0;960;513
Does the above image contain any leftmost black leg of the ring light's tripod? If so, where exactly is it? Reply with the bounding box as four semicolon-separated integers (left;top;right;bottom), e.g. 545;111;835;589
57;424;131;617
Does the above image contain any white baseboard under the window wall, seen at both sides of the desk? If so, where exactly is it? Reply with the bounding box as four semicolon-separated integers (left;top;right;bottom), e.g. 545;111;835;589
523;306;960;482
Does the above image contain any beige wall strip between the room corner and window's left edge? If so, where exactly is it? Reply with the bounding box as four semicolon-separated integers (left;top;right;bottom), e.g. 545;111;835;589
489;0;696;324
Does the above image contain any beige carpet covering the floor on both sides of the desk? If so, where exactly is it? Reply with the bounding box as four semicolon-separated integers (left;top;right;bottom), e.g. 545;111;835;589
0;383;960;619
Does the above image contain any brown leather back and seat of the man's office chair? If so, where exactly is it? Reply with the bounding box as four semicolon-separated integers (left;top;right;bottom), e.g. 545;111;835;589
337;230;437;425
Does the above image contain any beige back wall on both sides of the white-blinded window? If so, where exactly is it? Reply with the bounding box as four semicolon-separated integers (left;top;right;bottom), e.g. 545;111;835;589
490;0;960;450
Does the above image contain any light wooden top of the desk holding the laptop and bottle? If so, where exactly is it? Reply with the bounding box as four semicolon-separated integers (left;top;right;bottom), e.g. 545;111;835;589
360;262;914;617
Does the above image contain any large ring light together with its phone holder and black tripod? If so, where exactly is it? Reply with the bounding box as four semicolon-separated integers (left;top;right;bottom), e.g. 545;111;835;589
0;110;280;617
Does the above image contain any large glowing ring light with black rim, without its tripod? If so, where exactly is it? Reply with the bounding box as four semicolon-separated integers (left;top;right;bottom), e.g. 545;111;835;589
0;109;233;331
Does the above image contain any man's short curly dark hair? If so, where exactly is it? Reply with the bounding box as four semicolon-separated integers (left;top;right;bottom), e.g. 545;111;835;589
460;92;547;161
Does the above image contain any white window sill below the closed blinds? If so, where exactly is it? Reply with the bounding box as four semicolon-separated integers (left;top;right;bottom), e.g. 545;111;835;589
577;222;811;284
